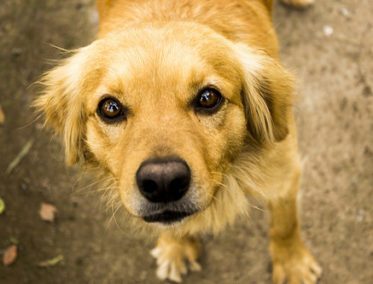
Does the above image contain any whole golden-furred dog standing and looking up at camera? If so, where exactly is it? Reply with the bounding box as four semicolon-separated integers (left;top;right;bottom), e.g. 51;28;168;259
35;0;321;284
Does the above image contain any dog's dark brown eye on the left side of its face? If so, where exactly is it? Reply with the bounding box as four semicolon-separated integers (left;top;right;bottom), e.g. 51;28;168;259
97;97;126;123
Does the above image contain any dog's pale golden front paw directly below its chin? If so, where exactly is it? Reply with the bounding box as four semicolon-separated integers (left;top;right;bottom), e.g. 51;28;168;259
151;232;201;282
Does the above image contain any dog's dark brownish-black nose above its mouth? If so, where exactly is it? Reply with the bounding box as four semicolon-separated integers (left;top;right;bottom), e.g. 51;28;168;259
136;158;191;203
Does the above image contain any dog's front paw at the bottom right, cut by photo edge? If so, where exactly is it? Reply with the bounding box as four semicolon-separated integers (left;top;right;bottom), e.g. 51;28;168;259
271;242;322;284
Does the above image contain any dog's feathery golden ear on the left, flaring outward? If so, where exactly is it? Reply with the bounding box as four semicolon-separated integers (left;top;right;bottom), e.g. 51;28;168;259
34;54;86;165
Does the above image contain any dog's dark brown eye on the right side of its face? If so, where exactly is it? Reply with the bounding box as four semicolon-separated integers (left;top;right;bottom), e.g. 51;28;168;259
194;87;224;113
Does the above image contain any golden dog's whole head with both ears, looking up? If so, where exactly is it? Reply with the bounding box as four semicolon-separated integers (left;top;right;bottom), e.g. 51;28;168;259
36;24;290;233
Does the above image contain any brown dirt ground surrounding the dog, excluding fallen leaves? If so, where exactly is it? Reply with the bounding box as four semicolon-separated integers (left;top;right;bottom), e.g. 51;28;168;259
0;0;373;284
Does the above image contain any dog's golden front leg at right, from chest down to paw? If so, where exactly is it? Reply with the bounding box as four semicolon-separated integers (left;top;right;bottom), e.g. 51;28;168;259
269;173;321;284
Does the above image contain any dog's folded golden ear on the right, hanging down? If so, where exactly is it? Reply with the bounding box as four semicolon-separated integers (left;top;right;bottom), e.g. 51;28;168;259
235;44;293;143
